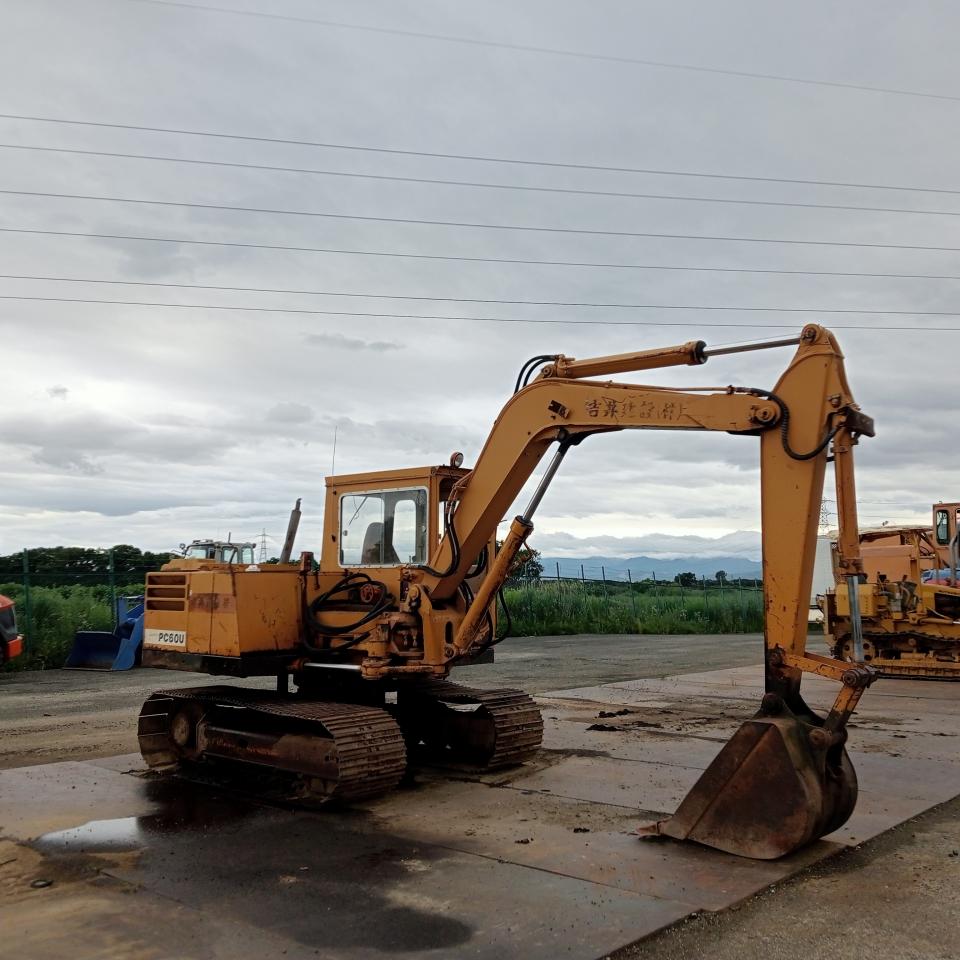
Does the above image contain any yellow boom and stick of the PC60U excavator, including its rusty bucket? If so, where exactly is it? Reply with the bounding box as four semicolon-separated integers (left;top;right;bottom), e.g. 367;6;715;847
408;324;875;859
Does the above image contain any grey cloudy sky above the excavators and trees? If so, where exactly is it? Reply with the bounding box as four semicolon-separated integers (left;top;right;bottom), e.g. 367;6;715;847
0;0;960;556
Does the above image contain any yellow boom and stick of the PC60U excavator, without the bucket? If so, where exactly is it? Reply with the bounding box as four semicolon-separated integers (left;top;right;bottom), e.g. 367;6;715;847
417;324;873;655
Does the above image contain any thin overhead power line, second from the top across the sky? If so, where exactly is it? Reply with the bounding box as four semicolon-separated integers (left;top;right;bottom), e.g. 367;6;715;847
0;113;960;195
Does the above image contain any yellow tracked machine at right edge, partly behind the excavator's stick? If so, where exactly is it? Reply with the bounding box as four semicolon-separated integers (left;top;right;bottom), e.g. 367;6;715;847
819;502;960;680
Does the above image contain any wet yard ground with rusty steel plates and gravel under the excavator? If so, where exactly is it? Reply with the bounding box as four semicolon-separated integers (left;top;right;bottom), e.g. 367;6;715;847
0;637;960;960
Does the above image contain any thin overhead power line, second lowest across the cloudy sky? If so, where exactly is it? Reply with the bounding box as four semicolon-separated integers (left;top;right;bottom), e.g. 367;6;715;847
9;273;960;317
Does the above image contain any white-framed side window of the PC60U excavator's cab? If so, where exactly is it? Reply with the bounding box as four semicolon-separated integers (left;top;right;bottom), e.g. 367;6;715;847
340;487;427;567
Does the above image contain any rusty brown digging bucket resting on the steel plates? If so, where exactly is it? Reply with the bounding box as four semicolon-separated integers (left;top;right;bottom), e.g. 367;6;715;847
640;697;857;860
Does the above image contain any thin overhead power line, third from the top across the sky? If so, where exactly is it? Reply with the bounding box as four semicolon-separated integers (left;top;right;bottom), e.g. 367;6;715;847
0;143;960;217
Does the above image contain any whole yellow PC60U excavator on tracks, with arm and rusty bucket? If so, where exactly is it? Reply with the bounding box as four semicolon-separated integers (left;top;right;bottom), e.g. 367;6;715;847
139;325;876;859
